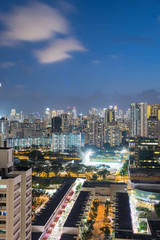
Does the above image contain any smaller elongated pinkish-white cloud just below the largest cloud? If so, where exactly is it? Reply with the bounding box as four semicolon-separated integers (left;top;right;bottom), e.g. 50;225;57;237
35;38;86;63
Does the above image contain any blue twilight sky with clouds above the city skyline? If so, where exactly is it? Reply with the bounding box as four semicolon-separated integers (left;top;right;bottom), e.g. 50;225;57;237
0;0;160;114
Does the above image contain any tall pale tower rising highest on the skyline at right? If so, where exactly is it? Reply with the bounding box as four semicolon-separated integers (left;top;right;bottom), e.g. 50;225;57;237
130;103;147;137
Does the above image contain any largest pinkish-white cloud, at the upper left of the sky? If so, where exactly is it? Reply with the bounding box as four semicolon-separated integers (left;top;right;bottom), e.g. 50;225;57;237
0;2;69;45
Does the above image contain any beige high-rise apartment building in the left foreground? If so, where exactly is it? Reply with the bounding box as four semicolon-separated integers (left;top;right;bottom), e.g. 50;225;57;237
0;148;32;240
